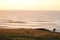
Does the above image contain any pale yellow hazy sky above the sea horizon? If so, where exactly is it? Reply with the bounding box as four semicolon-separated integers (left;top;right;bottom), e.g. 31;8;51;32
0;0;60;10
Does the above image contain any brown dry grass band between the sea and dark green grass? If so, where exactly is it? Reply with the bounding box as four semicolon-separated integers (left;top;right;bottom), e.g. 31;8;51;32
0;29;60;37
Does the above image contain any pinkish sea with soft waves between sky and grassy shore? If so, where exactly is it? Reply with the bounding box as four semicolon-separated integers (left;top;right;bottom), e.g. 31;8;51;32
0;11;60;32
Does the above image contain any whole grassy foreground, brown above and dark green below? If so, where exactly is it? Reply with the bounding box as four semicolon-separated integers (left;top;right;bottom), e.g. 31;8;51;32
0;29;60;40
